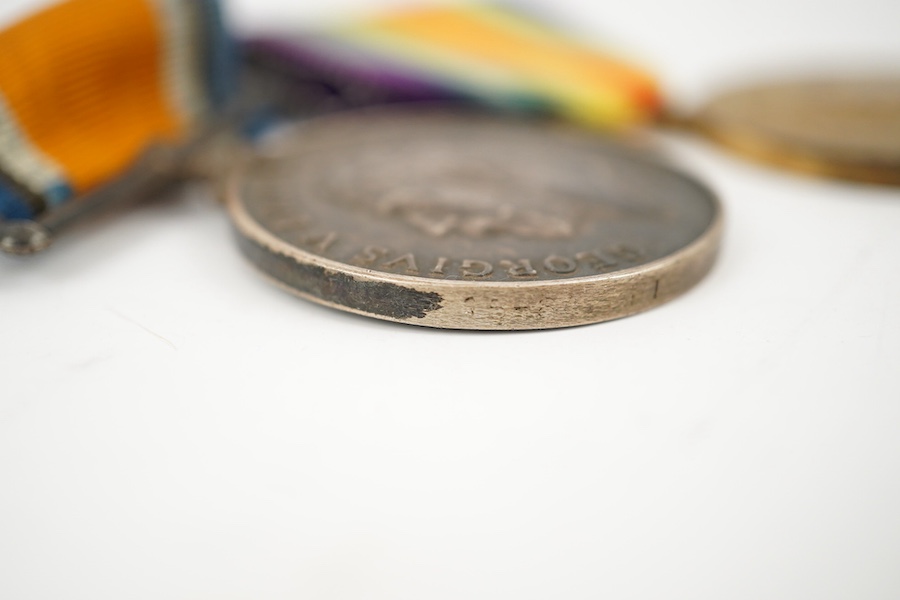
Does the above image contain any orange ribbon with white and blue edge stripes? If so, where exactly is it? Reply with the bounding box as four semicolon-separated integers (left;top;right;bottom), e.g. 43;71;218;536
0;0;233;219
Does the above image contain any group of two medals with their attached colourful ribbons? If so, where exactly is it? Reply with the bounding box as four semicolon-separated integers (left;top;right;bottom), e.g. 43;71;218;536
0;0;900;329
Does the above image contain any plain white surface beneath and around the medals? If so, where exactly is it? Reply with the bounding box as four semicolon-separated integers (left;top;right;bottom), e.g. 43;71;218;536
0;0;900;600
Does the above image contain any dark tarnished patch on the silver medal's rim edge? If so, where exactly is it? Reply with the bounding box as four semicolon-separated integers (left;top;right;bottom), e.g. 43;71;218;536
237;231;443;320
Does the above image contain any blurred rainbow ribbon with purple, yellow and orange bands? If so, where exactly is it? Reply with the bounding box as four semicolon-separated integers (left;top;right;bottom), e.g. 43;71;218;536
248;3;662;129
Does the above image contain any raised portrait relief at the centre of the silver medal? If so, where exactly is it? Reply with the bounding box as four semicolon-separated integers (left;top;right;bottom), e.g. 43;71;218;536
328;144;586;240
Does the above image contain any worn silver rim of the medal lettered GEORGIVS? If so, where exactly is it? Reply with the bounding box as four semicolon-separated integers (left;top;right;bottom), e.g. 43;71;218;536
225;175;724;330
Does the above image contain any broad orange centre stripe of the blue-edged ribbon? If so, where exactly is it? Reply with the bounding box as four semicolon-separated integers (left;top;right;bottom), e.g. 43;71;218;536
0;0;188;193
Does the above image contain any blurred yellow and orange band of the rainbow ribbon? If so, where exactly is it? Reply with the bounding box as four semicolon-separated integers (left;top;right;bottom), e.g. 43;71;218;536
333;5;661;127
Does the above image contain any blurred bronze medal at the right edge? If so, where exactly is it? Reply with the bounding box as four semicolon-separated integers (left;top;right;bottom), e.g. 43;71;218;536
688;77;900;185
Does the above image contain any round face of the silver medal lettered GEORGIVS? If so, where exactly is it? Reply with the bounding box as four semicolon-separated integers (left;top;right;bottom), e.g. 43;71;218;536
245;110;711;281
